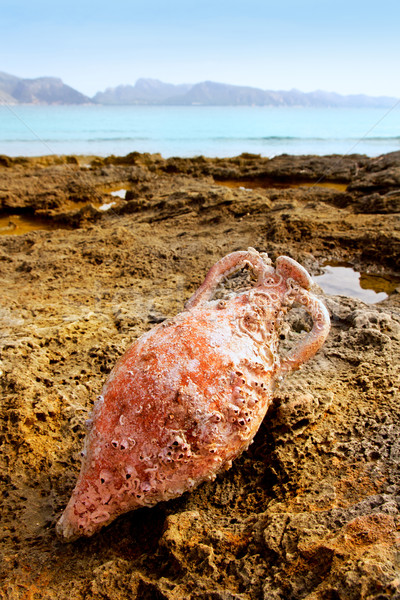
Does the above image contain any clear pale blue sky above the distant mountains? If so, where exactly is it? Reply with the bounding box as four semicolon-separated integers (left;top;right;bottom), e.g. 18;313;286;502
0;0;400;98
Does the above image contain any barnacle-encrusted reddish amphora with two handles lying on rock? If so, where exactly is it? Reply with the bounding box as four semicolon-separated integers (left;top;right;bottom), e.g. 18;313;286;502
57;249;329;540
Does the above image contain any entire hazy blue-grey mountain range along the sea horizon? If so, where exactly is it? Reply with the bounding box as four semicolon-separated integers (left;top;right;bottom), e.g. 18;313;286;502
0;72;397;108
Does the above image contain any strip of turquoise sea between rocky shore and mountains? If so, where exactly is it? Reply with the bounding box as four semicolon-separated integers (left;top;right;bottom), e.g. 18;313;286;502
0;105;400;158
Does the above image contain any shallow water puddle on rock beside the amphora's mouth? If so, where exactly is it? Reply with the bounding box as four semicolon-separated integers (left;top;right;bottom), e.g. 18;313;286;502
313;263;400;304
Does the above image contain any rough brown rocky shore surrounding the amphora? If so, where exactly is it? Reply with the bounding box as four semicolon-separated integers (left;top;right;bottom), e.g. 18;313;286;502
0;152;400;600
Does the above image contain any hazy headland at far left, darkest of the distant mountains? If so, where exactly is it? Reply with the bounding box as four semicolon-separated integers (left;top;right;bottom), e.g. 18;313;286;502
0;73;92;104
